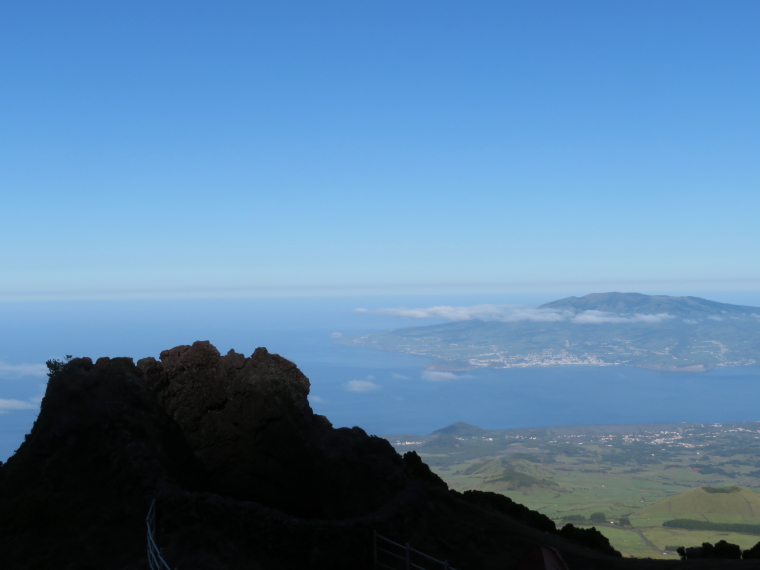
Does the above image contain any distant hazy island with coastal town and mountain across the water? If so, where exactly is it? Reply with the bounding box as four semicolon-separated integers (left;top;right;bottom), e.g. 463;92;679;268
336;292;760;371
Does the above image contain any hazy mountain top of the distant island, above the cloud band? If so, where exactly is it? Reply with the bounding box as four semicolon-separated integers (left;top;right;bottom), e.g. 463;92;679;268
539;292;760;317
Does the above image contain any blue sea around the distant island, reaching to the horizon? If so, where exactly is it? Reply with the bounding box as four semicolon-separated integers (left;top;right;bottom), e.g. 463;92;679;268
0;298;760;460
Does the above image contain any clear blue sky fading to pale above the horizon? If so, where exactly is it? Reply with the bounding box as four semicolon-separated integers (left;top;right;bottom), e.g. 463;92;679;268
0;0;760;300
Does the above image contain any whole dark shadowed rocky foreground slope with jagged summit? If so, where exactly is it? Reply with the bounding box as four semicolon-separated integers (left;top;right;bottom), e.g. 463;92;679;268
0;342;751;570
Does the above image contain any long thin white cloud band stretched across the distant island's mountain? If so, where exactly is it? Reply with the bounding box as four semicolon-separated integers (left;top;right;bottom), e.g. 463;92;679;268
354;305;675;324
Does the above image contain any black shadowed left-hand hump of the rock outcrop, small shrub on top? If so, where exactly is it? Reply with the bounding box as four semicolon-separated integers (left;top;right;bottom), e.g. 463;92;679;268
0;352;203;568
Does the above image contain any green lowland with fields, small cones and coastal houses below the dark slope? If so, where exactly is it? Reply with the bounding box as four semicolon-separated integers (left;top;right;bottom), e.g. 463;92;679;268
389;422;760;559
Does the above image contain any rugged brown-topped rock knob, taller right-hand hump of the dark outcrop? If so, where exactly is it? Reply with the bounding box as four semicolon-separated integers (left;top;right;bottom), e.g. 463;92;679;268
138;342;405;518
